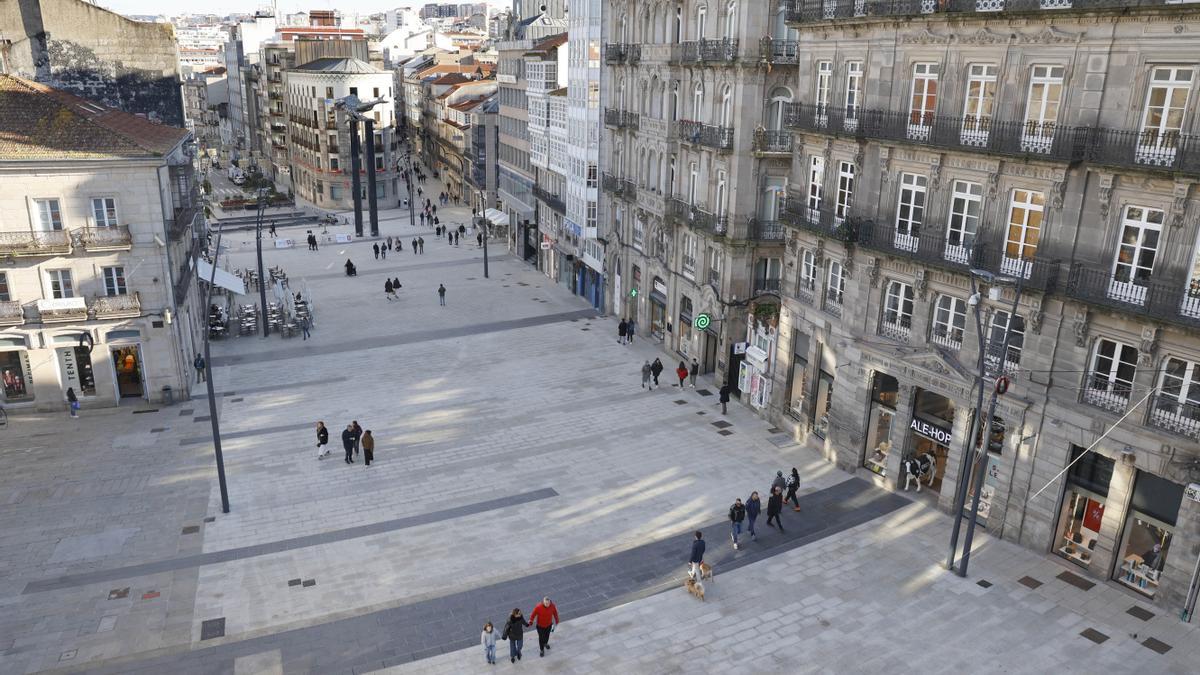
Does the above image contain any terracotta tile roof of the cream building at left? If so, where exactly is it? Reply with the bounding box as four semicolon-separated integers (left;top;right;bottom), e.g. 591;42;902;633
0;74;187;160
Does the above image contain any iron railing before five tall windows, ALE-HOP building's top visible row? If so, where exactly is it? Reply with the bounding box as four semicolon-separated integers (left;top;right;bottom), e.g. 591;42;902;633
785;103;1092;162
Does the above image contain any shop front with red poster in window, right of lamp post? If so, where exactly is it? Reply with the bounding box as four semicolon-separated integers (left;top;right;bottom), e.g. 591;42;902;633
1054;446;1116;568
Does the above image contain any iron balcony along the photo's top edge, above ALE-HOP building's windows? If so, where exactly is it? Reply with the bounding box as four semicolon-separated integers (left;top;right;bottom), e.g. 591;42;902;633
787;0;1172;23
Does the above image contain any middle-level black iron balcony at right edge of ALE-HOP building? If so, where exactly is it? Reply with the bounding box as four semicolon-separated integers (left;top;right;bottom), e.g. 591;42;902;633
1067;263;1200;327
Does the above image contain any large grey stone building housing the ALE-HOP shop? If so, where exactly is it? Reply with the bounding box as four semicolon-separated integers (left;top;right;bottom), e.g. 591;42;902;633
768;0;1200;611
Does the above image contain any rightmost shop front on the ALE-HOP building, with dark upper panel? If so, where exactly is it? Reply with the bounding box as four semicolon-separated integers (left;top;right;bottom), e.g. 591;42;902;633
1114;471;1183;597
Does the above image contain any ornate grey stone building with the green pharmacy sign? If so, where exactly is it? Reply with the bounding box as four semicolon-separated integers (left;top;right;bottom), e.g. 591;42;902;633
601;0;796;384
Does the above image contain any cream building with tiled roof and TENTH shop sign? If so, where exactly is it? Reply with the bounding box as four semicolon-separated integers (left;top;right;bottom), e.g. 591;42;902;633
0;74;206;411
